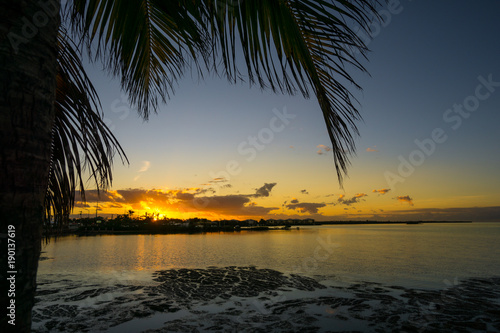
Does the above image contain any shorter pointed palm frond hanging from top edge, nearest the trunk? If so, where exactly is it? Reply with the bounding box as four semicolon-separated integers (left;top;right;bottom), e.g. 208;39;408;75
71;0;204;119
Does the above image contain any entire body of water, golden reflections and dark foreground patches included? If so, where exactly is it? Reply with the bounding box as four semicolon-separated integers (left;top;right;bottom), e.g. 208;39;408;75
34;223;500;332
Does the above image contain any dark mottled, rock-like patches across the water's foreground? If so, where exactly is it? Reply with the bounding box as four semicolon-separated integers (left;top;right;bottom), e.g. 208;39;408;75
33;266;500;332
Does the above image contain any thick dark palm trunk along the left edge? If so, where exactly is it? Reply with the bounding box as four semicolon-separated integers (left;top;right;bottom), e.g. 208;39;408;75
0;0;60;332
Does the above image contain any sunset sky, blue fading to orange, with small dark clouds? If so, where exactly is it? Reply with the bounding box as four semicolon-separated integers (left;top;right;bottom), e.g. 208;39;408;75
73;0;500;221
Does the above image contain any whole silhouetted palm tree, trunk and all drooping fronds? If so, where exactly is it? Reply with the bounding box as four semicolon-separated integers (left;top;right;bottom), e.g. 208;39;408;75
0;0;376;332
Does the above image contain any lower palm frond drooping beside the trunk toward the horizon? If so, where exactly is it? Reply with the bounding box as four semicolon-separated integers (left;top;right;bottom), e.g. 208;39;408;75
45;31;128;230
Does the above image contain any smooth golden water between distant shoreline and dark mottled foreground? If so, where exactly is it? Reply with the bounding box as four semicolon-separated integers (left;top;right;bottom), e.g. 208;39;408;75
38;223;500;288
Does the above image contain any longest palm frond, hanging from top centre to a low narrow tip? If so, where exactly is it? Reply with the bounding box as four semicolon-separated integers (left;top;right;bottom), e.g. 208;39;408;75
204;0;378;185
